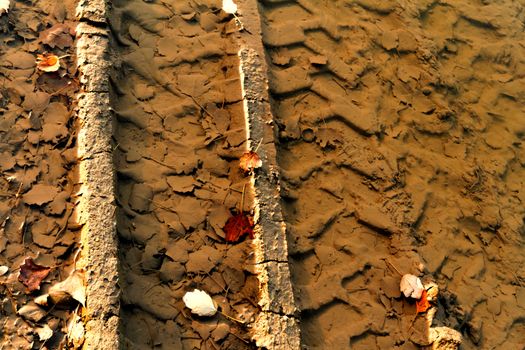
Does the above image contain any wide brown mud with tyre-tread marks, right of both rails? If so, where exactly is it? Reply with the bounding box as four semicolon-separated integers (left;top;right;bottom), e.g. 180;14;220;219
260;0;525;349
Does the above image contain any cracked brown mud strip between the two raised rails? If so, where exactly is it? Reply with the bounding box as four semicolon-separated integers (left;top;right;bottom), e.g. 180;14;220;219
110;0;259;349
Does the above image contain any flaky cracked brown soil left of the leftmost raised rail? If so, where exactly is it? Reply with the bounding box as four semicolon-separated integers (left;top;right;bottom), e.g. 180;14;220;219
0;1;79;349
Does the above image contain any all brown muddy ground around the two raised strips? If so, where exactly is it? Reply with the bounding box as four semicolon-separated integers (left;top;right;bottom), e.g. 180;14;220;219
0;0;525;349
